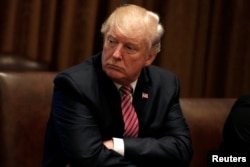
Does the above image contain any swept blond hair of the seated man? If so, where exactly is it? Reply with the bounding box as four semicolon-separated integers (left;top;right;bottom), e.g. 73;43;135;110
101;5;164;54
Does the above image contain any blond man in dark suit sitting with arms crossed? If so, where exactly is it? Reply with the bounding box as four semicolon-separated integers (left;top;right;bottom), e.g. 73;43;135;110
43;5;192;167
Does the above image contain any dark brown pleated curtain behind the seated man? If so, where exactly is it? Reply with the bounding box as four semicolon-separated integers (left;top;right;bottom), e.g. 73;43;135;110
0;0;250;97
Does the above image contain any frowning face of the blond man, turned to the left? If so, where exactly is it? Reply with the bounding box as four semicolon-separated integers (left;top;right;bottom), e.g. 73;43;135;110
102;28;155;85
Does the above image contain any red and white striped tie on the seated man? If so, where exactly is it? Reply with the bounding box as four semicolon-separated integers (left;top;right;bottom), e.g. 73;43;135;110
120;86;139;137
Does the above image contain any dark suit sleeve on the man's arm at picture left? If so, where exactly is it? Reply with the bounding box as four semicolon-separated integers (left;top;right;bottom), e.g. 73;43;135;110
52;75;136;167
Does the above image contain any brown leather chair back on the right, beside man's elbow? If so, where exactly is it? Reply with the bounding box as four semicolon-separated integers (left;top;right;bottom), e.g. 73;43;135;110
181;98;236;167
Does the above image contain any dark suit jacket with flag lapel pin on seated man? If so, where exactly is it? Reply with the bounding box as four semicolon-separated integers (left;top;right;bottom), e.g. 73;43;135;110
43;53;192;167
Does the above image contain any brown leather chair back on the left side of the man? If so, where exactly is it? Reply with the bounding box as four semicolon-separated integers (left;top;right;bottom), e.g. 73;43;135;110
0;72;55;167
